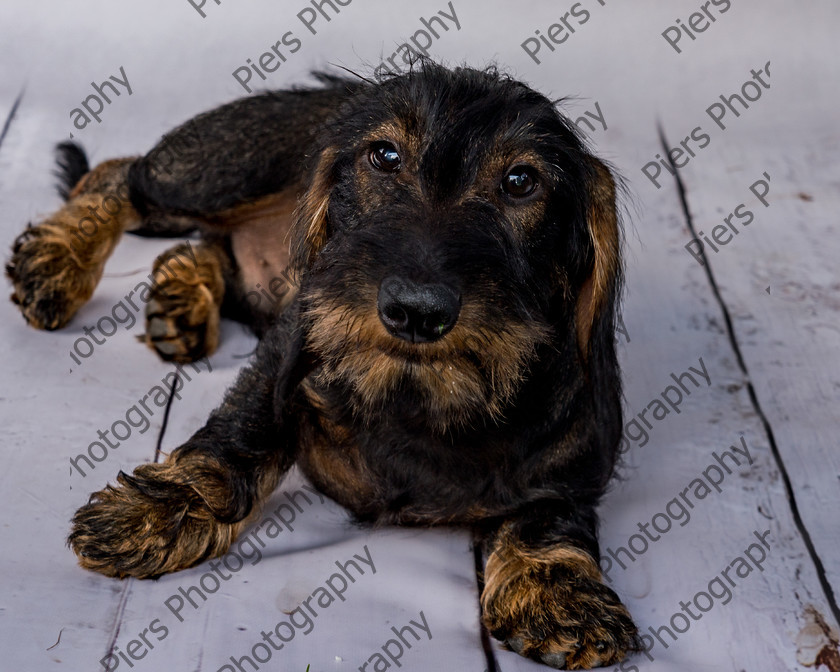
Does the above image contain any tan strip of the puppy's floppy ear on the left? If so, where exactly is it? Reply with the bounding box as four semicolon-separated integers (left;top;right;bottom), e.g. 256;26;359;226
290;147;337;274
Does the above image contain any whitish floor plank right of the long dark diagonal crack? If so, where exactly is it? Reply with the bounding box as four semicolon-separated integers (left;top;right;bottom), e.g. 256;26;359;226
636;5;840;664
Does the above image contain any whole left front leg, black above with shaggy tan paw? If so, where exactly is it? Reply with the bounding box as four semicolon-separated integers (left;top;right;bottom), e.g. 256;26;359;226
68;304;306;578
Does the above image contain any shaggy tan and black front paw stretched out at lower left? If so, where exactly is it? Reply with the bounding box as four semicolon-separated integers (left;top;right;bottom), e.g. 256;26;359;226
67;463;238;578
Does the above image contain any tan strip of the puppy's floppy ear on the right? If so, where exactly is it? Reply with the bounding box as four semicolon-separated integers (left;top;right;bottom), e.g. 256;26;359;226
575;157;622;360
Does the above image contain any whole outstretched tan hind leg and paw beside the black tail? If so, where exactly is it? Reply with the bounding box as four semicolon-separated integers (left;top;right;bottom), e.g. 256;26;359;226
6;150;140;329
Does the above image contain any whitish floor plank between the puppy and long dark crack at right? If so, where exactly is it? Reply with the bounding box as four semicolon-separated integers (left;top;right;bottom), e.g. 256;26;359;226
492;129;825;672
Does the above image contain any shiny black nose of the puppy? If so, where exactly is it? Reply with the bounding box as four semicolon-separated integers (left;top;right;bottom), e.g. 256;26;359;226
378;276;461;343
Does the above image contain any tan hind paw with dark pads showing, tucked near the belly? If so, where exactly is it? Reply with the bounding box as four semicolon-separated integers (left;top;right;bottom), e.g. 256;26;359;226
145;243;230;362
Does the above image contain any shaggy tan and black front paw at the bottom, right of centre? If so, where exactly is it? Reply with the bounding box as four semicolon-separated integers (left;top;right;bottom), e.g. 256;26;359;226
482;549;639;670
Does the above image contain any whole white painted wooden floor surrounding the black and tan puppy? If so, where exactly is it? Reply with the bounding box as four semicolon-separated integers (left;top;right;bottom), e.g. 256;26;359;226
0;0;840;672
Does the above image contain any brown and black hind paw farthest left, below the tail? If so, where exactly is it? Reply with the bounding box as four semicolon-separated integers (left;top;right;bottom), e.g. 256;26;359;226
6;223;99;330
